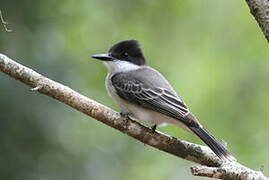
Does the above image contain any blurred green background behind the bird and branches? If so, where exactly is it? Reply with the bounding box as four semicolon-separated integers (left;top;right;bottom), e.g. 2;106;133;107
0;0;269;180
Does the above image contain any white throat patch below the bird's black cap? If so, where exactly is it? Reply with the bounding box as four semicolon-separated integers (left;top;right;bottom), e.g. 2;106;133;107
104;60;141;74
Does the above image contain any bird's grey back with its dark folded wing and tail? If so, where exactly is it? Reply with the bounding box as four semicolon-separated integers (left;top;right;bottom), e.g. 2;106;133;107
111;69;234;161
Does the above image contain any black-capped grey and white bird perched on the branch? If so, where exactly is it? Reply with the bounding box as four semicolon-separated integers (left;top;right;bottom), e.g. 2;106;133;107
91;40;234;161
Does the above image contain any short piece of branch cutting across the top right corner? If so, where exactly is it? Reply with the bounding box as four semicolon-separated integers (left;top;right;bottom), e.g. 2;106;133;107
246;0;269;42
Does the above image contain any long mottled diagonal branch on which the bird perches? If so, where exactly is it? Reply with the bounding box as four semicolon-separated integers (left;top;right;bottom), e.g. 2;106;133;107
0;54;268;180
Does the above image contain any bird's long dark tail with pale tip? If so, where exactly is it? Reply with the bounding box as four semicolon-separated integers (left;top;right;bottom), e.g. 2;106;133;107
190;127;235;161
